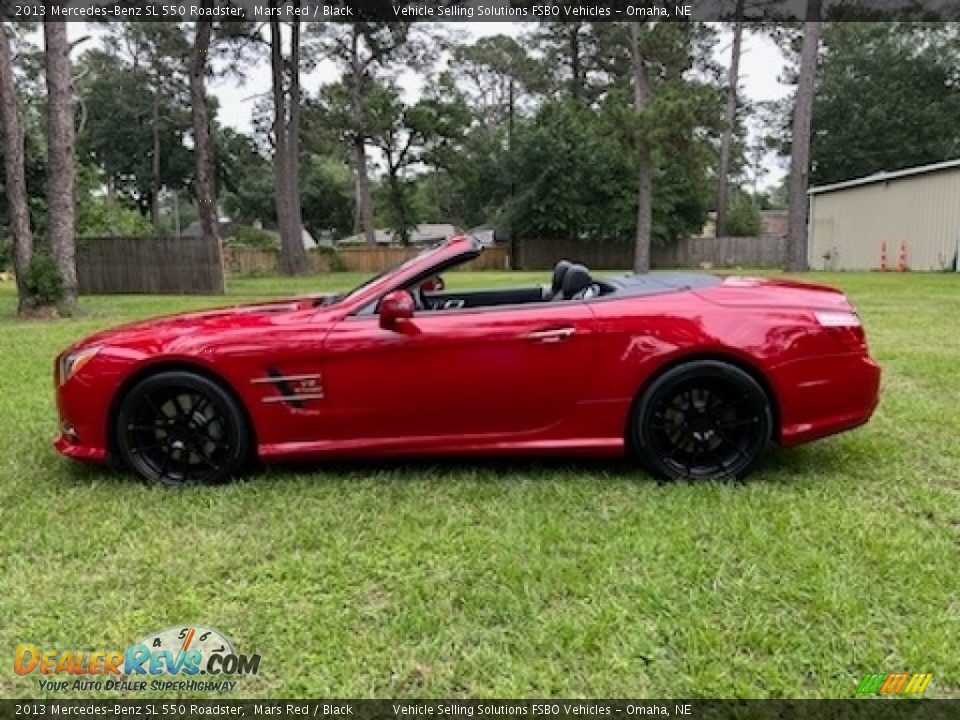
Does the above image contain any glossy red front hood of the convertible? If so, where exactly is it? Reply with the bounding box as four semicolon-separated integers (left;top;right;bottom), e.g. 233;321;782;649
73;297;323;350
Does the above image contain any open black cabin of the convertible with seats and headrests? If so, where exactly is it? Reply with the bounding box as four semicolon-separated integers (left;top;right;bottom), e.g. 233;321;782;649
408;260;614;310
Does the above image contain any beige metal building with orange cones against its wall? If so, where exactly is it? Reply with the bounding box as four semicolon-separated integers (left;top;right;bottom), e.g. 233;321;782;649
808;159;960;270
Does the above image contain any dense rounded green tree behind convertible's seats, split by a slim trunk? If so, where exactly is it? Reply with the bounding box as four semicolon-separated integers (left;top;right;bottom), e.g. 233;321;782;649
501;98;712;243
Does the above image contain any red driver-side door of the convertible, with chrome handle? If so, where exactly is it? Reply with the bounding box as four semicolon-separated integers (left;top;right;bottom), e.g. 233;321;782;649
324;302;593;440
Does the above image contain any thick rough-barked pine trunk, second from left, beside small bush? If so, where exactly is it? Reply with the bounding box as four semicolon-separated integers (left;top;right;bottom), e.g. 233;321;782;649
43;18;77;312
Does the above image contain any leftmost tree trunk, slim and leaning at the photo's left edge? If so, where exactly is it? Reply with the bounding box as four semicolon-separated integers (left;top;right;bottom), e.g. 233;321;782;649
0;23;36;315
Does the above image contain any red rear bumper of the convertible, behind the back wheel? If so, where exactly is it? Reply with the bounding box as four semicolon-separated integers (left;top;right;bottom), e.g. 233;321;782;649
771;353;881;447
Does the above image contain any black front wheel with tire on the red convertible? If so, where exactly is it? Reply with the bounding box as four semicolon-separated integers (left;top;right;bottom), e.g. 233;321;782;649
115;371;251;485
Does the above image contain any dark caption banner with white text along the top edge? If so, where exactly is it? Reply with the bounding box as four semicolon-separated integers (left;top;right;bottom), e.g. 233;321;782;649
0;0;960;23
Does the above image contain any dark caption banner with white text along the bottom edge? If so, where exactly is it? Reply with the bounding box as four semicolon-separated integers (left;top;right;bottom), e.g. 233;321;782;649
0;699;960;720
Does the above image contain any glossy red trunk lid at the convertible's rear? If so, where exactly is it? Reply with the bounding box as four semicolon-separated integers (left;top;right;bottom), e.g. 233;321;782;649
695;276;851;310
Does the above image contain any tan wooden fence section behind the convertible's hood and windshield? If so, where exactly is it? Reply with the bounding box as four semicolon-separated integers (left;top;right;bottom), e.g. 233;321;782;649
223;246;509;275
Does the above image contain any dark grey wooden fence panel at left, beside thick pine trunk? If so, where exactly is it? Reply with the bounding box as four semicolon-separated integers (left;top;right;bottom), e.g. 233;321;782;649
77;237;224;295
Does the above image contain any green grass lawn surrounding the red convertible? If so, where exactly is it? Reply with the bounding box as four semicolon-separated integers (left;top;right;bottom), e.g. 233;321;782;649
0;273;960;697
